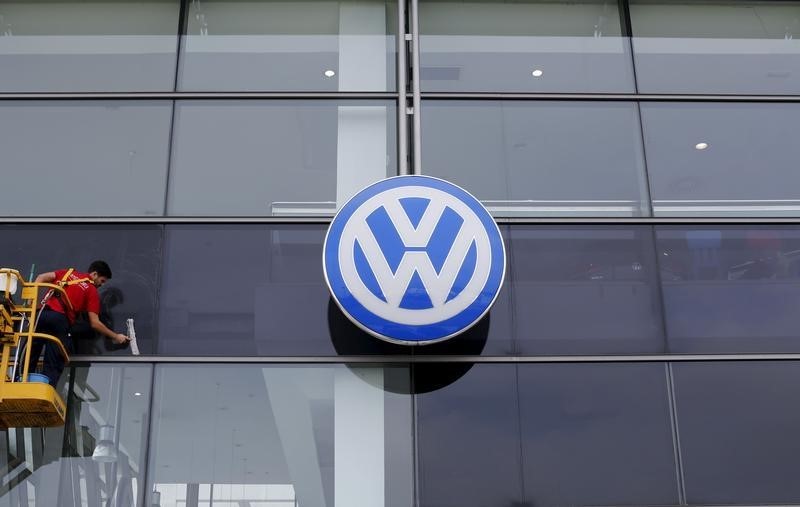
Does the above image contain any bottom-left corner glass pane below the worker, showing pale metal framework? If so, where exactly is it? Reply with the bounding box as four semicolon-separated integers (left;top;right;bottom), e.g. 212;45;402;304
0;365;152;507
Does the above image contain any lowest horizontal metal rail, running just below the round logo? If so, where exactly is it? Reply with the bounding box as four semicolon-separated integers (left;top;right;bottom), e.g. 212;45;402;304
71;354;800;365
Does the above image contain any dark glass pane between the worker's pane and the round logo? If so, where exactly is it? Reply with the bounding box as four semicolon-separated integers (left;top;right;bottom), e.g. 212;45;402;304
159;225;334;356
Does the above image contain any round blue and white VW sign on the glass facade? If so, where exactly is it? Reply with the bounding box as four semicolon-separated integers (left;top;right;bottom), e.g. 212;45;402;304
322;176;506;345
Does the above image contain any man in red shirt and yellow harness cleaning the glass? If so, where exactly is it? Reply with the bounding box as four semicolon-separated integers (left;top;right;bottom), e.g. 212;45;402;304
29;260;128;387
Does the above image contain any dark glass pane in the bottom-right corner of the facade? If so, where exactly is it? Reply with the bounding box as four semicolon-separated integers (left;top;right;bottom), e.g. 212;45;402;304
673;362;800;505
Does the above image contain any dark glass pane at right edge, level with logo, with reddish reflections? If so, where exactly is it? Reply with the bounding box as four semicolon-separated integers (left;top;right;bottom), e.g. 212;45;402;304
656;226;800;353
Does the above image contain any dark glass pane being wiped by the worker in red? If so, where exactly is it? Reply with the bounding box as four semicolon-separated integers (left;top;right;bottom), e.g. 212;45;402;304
0;225;162;355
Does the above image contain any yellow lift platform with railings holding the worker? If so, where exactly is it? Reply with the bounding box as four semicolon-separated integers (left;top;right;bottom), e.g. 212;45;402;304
0;268;69;429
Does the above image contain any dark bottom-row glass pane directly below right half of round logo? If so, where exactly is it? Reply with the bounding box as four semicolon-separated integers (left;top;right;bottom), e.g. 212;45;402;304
415;364;523;507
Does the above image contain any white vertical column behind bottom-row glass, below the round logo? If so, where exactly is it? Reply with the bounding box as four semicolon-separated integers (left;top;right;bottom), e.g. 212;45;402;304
334;367;386;507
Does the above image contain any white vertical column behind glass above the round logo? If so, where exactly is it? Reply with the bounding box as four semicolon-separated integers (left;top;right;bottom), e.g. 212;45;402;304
336;2;388;204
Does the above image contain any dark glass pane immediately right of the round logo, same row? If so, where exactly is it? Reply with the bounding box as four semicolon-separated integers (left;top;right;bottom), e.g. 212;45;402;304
509;226;665;355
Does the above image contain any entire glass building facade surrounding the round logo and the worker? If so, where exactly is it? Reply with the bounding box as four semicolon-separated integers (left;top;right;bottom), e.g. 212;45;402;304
0;0;800;507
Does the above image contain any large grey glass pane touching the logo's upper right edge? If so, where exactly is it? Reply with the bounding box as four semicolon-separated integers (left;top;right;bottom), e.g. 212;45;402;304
422;101;646;216
